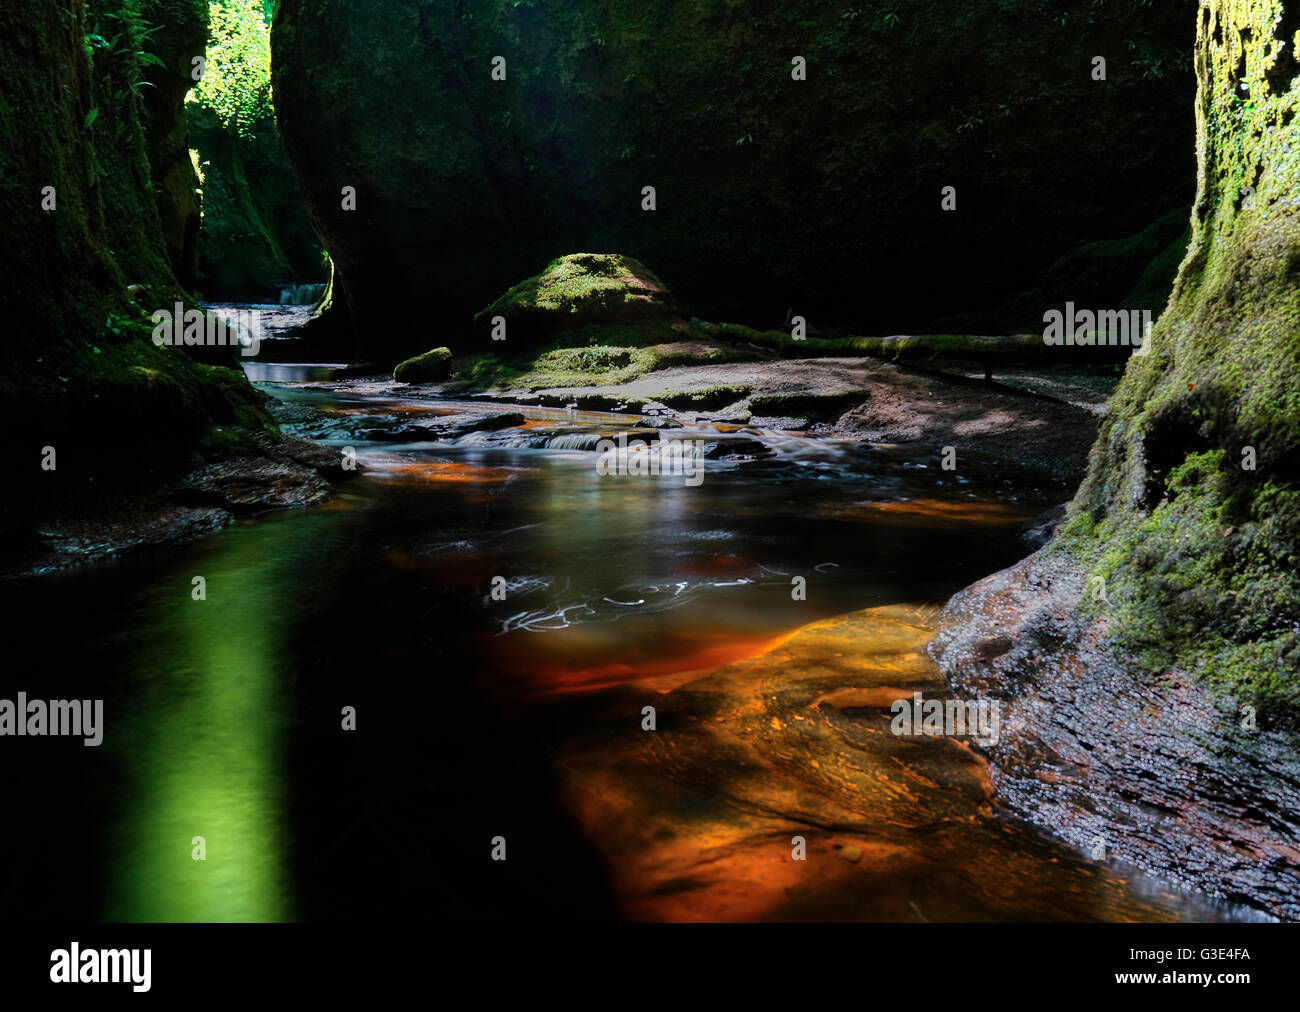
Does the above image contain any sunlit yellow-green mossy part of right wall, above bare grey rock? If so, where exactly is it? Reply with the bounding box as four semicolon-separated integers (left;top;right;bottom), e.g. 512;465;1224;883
1065;0;1300;725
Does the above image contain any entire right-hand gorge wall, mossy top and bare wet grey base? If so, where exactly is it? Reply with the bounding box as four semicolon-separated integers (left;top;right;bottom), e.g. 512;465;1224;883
932;0;1300;920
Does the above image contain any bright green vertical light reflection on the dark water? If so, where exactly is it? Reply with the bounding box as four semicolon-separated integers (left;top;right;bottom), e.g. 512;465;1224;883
105;499;343;922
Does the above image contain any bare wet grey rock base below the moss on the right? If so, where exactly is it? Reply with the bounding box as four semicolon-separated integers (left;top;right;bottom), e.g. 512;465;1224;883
931;550;1300;920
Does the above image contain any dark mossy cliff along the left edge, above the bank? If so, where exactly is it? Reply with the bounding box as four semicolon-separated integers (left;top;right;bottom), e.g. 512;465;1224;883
0;0;263;499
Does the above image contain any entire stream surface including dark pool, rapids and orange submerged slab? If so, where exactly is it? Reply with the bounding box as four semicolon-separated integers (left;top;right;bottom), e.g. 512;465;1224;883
7;348;1274;921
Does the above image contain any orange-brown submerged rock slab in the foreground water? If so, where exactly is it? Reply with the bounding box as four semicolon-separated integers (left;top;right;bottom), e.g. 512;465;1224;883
558;606;1214;921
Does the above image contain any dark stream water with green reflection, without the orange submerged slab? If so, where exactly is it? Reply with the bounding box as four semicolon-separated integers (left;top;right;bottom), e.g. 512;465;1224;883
0;377;1258;921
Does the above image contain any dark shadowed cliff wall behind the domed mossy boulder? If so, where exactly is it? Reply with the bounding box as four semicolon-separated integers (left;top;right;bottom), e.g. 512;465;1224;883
272;0;1195;360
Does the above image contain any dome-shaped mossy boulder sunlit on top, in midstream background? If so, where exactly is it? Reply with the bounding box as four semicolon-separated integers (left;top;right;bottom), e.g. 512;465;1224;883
475;254;677;346
